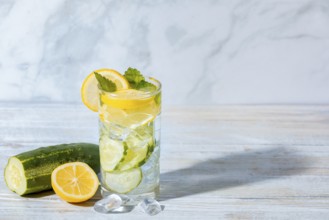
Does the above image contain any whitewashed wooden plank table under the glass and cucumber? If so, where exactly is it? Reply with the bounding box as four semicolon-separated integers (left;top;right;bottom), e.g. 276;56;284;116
0;103;329;220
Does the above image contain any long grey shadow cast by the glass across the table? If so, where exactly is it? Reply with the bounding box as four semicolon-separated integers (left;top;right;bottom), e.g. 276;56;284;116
160;147;309;201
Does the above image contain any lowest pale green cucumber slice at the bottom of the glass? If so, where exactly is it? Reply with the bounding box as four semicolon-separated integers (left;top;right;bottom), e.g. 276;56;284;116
105;168;143;193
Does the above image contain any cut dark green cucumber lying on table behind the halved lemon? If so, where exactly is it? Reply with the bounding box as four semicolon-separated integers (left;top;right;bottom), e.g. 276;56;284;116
4;143;100;195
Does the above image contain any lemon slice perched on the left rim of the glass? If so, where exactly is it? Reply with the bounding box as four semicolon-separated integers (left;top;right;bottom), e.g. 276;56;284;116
81;69;129;112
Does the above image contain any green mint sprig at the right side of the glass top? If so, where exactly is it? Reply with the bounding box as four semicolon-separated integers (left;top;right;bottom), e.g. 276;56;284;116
124;67;156;92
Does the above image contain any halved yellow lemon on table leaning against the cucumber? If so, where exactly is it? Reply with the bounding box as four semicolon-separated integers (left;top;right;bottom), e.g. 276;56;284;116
51;162;99;203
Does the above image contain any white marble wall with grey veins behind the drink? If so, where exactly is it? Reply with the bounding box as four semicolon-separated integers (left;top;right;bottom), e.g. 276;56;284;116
0;0;329;105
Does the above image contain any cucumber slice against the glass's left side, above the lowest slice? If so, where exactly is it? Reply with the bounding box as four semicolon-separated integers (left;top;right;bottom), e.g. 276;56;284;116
99;136;126;171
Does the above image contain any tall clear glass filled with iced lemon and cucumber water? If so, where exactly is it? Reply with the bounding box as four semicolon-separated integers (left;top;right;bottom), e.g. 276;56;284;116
98;77;161;199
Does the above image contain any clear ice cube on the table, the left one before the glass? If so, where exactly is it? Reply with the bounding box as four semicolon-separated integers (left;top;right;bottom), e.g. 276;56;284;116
94;194;122;213
